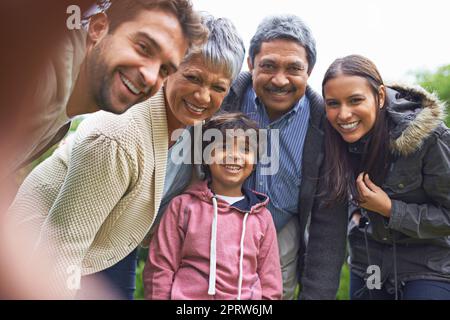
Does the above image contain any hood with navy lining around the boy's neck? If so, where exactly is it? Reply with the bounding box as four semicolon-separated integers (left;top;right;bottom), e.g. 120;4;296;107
184;180;269;214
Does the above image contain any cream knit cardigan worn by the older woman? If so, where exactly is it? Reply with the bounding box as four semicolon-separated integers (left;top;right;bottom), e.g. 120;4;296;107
10;89;168;298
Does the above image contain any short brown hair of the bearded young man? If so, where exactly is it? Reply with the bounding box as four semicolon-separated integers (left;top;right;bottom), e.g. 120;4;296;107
106;0;208;48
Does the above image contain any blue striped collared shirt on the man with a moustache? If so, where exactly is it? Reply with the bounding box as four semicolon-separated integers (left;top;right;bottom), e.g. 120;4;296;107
241;86;310;231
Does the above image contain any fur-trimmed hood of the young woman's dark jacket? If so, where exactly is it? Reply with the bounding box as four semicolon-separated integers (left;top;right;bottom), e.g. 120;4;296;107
386;84;445;156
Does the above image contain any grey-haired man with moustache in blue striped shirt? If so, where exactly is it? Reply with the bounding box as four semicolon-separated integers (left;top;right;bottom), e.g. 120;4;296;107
222;15;347;299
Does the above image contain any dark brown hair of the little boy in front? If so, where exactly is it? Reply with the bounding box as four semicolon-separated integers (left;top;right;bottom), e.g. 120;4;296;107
202;112;259;180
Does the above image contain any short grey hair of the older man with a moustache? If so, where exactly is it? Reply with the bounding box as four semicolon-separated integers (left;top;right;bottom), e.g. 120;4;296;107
249;14;316;74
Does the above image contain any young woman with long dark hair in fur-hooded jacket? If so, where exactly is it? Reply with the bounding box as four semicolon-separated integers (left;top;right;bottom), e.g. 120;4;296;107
322;55;450;299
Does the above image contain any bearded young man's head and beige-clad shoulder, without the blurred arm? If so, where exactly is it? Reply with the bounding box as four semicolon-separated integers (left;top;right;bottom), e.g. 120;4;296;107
4;0;206;175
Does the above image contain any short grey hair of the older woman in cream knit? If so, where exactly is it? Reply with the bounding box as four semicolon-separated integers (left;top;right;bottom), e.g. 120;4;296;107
184;12;245;80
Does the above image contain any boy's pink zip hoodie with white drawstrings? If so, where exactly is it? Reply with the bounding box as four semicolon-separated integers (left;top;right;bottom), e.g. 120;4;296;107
143;181;283;300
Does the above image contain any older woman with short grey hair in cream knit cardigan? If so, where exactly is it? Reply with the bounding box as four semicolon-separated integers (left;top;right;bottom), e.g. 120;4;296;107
10;14;245;299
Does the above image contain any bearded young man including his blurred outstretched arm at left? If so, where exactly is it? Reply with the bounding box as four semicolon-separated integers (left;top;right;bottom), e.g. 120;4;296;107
0;0;207;299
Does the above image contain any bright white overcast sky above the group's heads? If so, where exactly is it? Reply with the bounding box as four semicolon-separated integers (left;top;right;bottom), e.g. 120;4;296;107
192;0;450;90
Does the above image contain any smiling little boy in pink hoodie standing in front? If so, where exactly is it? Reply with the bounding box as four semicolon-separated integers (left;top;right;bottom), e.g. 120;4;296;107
144;113;282;300
